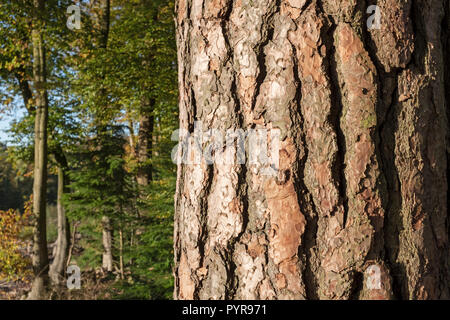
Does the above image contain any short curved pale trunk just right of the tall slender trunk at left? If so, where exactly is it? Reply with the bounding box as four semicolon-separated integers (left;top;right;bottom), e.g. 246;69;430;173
49;165;70;285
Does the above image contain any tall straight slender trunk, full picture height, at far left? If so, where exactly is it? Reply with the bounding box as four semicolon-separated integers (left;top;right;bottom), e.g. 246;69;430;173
28;0;48;300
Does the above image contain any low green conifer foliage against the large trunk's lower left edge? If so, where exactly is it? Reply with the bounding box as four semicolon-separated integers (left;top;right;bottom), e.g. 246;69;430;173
114;177;175;299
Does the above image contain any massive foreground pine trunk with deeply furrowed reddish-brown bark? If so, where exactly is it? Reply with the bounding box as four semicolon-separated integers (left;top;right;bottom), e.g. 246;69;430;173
174;0;450;299
